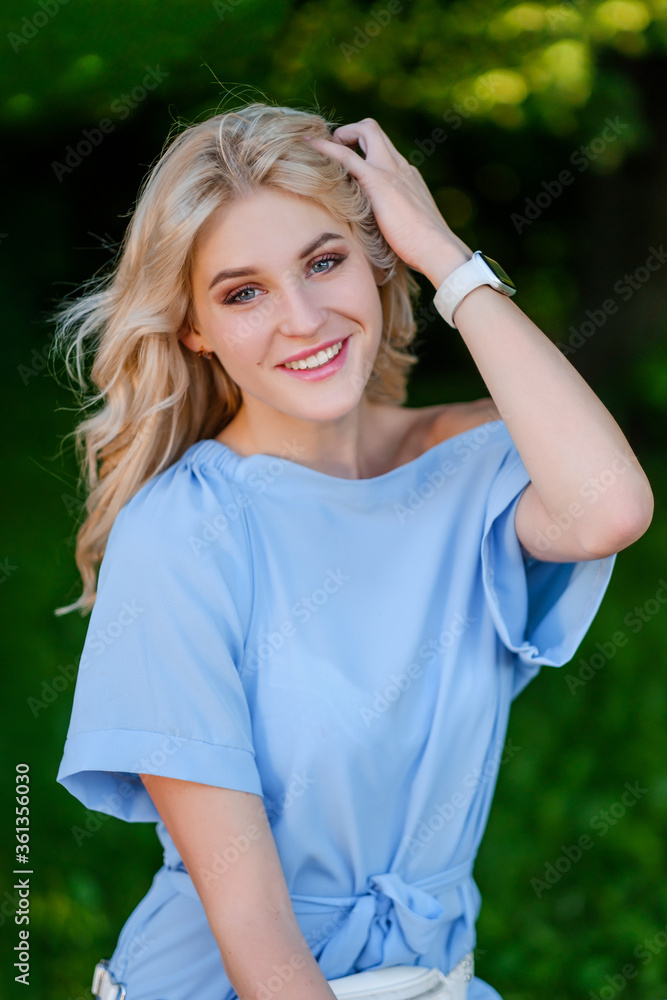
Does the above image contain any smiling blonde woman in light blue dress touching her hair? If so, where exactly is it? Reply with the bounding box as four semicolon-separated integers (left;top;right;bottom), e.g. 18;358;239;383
58;104;653;1000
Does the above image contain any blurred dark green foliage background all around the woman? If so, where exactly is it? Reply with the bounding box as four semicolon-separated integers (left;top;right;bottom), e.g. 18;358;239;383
0;0;667;1000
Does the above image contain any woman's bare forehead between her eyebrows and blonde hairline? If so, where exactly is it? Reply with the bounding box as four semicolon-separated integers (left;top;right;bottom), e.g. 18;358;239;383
195;187;352;267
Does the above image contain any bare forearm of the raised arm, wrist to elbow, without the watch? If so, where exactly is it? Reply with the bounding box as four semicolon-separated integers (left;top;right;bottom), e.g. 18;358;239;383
424;241;653;551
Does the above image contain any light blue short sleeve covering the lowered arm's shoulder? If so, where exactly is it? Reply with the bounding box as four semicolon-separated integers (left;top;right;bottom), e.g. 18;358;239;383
56;460;262;822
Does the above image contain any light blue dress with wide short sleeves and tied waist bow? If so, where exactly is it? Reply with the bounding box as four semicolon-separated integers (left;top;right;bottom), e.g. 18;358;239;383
57;420;616;1000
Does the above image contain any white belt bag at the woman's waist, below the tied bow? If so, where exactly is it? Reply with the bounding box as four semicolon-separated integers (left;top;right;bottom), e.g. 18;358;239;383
328;952;474;1000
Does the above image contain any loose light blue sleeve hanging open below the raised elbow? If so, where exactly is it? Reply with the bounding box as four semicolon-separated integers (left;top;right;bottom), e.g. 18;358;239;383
481;442;616;697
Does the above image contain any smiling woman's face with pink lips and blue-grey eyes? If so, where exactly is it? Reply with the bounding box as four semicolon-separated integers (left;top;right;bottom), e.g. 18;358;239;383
181;188;382;420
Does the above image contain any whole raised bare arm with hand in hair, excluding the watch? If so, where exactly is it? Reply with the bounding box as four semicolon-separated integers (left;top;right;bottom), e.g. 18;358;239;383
309;118;654;562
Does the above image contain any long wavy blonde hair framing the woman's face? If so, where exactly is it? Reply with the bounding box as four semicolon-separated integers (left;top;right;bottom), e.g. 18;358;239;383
52;102;419;615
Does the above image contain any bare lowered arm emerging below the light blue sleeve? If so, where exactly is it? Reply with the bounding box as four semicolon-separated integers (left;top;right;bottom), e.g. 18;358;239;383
140;774;335;1000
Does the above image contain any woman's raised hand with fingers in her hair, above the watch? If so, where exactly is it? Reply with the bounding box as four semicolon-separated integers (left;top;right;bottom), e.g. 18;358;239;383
308;118;472;288
